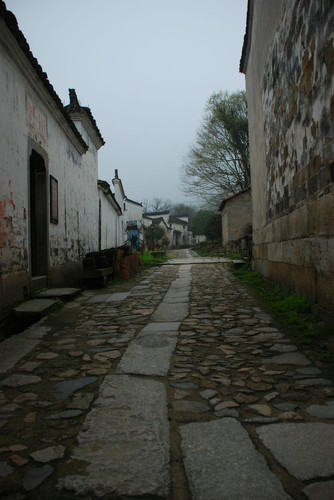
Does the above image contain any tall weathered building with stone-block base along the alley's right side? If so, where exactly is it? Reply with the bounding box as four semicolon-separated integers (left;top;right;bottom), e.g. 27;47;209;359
240;0;334;313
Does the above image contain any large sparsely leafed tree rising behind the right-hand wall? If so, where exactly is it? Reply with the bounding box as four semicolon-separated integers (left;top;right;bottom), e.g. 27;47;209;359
181;91;250;207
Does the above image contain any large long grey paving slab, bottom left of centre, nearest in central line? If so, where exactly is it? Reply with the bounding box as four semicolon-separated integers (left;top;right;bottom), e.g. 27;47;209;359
58;375;171;498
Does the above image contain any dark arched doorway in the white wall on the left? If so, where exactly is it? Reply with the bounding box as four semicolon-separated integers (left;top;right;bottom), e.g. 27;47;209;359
30;150;48;277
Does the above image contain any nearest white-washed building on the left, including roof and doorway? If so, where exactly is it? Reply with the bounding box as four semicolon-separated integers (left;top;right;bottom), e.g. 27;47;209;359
0;1;104;315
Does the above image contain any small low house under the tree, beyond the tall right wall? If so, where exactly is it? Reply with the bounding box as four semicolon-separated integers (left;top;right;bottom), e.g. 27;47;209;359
219;188;252;245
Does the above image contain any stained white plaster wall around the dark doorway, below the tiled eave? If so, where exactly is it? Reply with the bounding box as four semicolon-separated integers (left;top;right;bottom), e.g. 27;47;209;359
0;19;98;317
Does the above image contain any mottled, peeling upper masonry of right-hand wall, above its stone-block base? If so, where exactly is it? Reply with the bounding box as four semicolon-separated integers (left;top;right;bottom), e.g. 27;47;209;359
263;0;334;222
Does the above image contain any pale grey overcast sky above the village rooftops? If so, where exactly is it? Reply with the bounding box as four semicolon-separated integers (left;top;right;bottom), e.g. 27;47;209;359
5;0;247;204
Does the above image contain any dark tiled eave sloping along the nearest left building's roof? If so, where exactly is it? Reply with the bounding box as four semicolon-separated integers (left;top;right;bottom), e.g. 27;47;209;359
0;0;88;151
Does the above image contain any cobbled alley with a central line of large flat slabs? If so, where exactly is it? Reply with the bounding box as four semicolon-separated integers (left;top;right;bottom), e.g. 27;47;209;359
0;251;334;500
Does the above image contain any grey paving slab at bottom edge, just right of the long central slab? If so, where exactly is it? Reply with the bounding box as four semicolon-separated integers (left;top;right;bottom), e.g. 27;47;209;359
181;420;290;500
